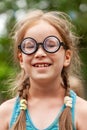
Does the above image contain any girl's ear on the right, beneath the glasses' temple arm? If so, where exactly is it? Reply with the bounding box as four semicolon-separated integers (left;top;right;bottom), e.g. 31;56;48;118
64;50;72;67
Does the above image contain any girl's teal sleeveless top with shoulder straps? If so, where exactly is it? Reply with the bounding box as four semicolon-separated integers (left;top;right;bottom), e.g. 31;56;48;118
10;90;76;130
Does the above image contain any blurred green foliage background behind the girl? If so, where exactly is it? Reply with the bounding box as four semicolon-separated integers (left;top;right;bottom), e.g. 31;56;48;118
0;0;87;103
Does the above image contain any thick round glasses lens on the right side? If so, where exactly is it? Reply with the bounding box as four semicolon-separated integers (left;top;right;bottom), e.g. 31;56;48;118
44;37;60;52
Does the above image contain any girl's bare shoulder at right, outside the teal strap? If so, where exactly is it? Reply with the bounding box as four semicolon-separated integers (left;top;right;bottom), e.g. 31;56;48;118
76;96;87;130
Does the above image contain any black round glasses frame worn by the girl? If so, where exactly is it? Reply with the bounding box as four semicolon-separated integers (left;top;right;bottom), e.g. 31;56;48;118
18;35;67;55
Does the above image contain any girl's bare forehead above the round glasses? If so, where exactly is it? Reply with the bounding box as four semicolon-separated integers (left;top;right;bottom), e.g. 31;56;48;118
24;20;62;41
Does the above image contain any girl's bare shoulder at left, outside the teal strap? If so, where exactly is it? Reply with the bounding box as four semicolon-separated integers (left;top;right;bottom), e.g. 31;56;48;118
0;98;16;130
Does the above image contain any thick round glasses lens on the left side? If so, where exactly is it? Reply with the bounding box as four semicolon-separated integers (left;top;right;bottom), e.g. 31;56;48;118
21;38;36;54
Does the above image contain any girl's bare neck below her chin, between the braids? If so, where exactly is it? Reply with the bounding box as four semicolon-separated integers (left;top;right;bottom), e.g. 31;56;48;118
29;77;65;98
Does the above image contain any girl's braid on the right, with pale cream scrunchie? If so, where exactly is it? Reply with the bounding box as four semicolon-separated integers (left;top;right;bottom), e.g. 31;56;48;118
59;69;73;130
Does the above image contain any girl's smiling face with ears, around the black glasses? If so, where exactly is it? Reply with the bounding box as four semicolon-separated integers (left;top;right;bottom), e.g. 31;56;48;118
18;21;71;81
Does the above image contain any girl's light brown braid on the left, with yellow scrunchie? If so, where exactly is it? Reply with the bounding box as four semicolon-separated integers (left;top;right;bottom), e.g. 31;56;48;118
11;78;30;130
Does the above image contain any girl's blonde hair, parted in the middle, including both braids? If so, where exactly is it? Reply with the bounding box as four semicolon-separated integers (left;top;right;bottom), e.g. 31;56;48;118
11;10;81;130
